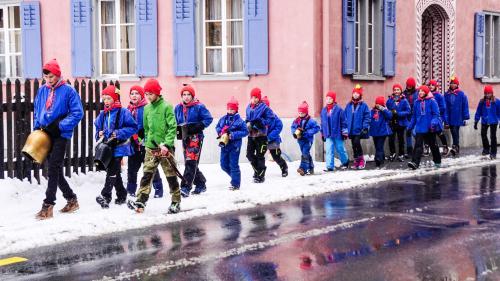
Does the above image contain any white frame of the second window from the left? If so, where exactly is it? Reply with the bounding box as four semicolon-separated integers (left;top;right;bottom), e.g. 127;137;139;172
96;0;137;78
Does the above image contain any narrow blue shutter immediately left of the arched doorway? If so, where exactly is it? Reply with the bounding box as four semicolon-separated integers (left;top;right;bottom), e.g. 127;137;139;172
382;0;396;76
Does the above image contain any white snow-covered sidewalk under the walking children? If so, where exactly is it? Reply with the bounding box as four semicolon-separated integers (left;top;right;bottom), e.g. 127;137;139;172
0;156;500;256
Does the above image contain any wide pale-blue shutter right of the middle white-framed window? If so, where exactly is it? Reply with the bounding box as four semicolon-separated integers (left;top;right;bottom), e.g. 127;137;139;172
243;0;269;75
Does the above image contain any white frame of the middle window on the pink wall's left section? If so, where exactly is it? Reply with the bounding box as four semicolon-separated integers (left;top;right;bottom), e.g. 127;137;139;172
200;0;245;75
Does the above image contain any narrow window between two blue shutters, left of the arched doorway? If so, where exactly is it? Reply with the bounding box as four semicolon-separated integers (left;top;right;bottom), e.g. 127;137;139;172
355;0;382;76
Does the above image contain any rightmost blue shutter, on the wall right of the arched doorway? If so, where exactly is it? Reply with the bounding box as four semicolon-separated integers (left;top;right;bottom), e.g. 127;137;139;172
474;13;486;78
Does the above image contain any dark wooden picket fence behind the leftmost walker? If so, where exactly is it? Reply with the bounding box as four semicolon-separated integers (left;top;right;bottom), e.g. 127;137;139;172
0;79;120;183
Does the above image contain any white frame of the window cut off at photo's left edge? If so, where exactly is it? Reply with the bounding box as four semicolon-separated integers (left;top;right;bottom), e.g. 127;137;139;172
0;3;23;79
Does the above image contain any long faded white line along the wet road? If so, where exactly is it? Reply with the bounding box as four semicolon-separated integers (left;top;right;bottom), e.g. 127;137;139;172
94;217;376;281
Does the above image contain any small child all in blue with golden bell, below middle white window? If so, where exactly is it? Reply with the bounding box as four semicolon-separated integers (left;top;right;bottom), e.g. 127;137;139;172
215;97;248;190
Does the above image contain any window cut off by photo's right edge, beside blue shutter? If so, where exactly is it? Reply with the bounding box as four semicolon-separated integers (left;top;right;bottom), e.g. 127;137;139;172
485;14;500;78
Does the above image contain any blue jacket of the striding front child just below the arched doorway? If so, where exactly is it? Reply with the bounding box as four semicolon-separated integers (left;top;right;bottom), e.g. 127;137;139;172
408;95;442;134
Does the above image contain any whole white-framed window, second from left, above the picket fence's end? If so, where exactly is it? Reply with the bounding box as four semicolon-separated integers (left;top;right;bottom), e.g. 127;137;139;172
98;0;136;76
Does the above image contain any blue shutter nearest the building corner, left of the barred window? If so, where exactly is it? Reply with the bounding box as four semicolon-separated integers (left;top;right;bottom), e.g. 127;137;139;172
342;0;357;75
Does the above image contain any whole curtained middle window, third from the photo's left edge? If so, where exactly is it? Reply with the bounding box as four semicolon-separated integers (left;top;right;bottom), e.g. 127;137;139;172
202;0;243;74
